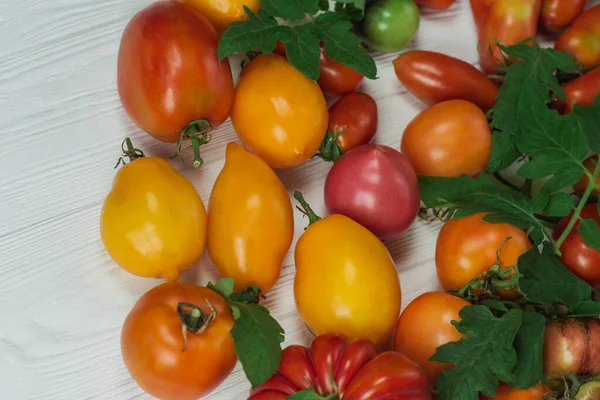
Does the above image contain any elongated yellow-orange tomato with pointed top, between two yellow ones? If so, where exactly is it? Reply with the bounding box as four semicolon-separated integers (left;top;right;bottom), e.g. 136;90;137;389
208;143;294;292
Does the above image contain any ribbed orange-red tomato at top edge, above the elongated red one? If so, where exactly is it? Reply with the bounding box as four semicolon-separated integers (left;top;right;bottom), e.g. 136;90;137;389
471;0;542;73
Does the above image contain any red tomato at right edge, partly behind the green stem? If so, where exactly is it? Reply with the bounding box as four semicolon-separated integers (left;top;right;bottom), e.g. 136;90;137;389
553;203;600;286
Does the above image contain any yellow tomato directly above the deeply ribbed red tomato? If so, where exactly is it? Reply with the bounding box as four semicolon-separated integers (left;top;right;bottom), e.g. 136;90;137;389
294;214;401;345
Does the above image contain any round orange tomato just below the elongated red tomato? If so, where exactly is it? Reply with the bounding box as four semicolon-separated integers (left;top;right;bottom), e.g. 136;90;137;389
401;100;492;177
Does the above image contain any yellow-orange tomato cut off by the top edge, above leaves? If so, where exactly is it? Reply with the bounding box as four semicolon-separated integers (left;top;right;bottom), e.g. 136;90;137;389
178;0;259;33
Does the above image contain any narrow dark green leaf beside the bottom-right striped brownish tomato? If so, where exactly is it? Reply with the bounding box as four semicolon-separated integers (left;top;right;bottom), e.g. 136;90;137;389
510;312;546;389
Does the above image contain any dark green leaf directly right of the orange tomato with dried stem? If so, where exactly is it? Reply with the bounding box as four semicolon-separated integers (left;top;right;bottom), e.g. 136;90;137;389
516;244;592;306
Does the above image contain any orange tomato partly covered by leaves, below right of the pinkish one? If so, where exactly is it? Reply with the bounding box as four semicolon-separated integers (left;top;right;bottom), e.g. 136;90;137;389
435;213;531;291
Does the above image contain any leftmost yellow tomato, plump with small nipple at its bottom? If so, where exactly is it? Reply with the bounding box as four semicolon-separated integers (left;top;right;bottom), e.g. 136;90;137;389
100;153;206;281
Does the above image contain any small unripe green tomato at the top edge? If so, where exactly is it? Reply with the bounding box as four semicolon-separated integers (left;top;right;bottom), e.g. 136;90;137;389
362;0;420;53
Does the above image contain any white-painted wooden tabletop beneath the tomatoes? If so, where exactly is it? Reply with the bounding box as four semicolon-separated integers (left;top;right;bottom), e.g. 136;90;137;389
0;0;592;400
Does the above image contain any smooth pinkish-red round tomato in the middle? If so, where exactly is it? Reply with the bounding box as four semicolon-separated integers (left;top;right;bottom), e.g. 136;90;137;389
325;144;421;240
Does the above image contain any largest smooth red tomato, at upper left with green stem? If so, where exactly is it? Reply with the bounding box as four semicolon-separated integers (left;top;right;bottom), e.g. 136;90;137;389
117;1;233;146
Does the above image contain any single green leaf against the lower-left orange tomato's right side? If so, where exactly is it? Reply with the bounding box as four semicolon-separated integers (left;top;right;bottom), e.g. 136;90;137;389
231;302;284;387
